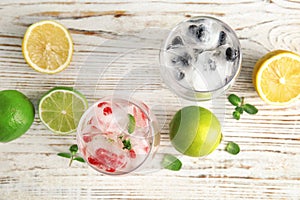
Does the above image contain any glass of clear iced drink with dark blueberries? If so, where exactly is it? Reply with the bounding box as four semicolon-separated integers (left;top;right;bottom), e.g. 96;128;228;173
160;16;242;101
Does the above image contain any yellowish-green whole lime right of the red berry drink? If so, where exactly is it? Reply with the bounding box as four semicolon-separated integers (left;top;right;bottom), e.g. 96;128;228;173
169;106;222;157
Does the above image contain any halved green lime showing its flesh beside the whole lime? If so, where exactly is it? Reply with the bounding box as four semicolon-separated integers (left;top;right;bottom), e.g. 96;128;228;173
39;87;88;134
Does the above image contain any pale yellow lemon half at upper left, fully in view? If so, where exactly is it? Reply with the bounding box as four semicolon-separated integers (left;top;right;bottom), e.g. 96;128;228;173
22;20;73;74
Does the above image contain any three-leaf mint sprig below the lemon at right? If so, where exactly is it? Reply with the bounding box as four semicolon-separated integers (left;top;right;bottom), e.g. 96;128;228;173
228;94;258;120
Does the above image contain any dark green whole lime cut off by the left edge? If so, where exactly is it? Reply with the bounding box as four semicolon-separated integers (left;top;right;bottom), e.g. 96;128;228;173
0;90;35;142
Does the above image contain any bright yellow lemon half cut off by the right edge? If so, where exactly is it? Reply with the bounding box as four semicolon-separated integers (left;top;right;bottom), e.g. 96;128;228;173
253;50;300;105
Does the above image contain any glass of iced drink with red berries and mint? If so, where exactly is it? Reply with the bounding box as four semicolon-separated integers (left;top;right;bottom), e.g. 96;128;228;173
77;97;160;175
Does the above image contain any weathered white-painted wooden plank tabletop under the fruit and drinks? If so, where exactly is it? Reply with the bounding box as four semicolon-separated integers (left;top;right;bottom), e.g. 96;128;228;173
0;0;300;200
